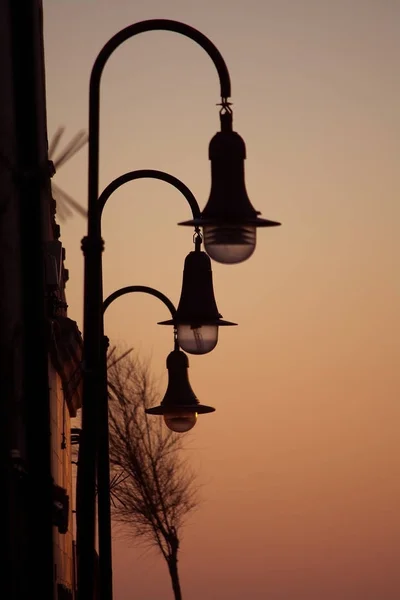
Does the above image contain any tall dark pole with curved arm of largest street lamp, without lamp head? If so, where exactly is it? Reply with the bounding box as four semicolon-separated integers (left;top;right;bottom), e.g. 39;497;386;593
77;19;239;600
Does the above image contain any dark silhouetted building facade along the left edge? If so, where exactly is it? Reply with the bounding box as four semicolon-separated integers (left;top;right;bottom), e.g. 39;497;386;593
0;0;82;600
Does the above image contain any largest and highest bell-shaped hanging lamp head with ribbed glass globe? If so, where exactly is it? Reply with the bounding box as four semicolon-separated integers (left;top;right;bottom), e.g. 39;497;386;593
179;112;280;264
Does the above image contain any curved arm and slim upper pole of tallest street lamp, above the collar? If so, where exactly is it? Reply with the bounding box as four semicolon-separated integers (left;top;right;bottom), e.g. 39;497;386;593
88;19;231;235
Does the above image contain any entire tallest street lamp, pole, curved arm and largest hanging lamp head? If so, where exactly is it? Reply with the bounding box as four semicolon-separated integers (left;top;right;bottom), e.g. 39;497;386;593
77;19;278;600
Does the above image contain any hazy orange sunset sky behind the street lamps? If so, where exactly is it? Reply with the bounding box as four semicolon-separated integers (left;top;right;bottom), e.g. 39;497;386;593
44;0;400;600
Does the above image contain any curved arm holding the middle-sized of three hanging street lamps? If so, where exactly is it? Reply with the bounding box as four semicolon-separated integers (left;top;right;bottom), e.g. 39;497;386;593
98;169;201;220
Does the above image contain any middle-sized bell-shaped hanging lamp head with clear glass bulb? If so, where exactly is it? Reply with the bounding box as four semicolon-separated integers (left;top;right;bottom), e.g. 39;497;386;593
159;250;236;354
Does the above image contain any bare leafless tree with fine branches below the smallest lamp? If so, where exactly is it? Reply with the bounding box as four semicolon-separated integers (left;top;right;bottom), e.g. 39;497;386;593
108;348;197;600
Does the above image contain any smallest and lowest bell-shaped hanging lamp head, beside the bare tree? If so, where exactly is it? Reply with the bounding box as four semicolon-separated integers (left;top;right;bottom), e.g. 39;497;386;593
146;349;215;433
